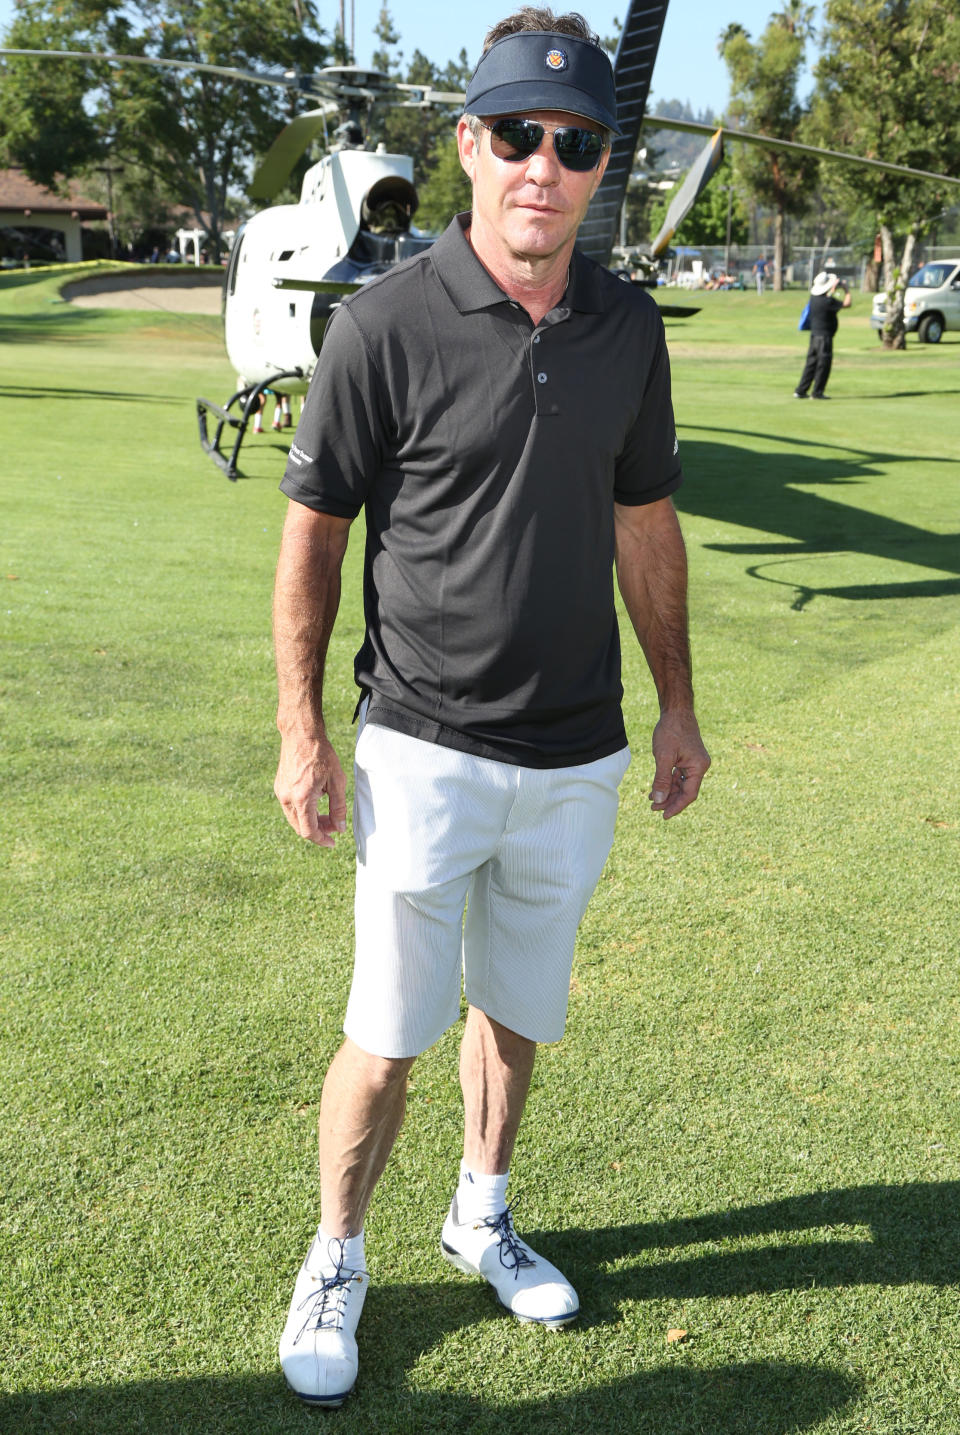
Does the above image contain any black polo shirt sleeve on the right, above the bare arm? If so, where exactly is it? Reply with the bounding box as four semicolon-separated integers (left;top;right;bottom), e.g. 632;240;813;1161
613;312;683;505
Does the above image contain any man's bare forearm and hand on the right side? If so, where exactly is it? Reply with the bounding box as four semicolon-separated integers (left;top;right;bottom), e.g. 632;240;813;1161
614;498;710;818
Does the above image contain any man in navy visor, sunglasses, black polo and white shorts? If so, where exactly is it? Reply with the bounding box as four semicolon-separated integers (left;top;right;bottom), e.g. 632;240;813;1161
274;9;710;1405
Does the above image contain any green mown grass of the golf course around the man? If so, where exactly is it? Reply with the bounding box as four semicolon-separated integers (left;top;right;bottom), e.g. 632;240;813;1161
0;271;960;1435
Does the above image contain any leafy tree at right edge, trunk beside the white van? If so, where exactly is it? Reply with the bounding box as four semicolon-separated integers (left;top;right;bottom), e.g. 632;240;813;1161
815;0;960;349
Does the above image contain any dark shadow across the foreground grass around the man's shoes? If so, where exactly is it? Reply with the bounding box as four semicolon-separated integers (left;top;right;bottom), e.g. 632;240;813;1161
7;1181;960;1435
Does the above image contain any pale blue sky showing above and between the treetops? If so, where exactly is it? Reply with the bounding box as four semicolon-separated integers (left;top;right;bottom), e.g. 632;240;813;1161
0;0;812;113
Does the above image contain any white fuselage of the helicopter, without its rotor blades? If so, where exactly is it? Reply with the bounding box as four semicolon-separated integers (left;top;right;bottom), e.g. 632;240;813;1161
224;148;432;393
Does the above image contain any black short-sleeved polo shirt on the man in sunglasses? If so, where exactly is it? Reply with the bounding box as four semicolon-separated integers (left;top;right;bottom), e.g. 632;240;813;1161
280;215;682;768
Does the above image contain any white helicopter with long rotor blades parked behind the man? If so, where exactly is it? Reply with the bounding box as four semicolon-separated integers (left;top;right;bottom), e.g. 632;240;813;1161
0;0;960;479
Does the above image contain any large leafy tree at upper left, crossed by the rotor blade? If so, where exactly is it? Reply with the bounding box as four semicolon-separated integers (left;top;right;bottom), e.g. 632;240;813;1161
1;0;327;248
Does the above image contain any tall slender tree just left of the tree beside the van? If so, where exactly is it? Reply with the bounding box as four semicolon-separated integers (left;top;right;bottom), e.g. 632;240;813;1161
719;12;817;290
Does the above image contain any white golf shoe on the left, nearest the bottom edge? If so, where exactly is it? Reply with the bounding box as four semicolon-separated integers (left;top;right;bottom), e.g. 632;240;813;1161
280;1233;370;1408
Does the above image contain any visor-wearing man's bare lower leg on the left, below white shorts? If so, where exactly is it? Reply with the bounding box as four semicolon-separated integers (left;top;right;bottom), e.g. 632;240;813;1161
319;1036;413;1238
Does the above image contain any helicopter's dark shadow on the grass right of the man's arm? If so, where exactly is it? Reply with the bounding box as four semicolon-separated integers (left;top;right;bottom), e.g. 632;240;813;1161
676;426;960;607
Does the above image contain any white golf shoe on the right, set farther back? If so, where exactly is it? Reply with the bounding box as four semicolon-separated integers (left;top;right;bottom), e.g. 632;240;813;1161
441;1197;580;1330
